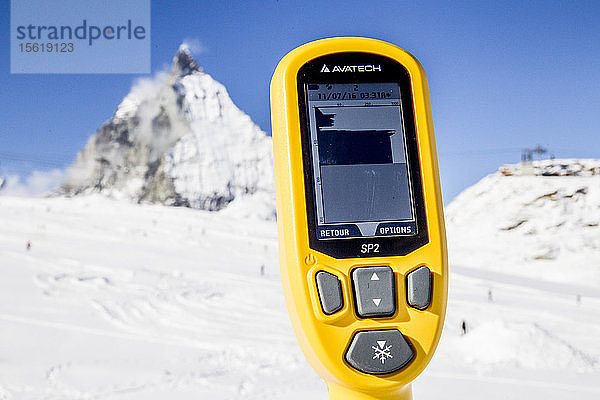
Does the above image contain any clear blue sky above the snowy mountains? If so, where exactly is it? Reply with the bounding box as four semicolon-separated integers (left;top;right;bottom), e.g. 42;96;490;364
0;0;600;201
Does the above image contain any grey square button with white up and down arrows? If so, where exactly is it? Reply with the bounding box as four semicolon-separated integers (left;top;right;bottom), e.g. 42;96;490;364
352;267;396;317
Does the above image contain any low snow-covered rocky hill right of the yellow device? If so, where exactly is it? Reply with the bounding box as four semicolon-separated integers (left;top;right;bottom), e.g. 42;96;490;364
446;160;600;286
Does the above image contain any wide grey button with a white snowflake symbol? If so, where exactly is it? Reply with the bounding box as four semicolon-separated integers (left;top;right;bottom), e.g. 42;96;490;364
346;329;415;375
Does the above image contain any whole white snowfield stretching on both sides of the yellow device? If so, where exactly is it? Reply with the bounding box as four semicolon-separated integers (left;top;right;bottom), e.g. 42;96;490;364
0;192;600;400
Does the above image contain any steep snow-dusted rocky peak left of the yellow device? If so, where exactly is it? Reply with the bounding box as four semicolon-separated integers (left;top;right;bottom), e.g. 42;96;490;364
58;45;273;210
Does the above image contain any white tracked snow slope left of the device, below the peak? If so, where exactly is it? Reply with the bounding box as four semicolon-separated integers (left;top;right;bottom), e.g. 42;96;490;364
0;197;316;399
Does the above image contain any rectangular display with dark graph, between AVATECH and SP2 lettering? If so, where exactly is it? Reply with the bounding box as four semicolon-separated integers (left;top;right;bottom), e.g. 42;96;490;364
306;82;417;240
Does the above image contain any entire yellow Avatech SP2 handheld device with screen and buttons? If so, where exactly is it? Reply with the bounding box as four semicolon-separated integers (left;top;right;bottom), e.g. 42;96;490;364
271;38;448;400
